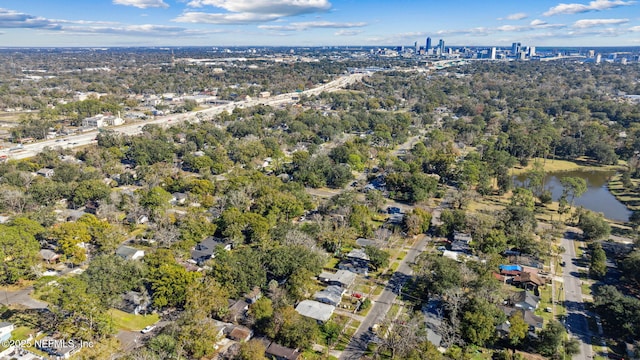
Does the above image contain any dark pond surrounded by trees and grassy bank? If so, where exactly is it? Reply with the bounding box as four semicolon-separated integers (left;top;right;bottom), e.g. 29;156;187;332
514;170;631;222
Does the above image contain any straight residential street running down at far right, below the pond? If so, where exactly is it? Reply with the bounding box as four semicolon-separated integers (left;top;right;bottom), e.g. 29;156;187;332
562;231;592;360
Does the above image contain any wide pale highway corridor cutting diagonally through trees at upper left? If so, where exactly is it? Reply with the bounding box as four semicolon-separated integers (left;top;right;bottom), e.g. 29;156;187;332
0;74;364;159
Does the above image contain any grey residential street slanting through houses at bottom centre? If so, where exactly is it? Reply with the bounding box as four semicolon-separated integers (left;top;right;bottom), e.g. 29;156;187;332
340;235;429;360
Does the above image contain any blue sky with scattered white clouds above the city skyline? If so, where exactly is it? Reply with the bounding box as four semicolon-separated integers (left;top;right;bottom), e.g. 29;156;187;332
0;0;640;47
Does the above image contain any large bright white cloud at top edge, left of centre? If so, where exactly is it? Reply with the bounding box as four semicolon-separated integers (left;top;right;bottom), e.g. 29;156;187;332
178;0;331;24
